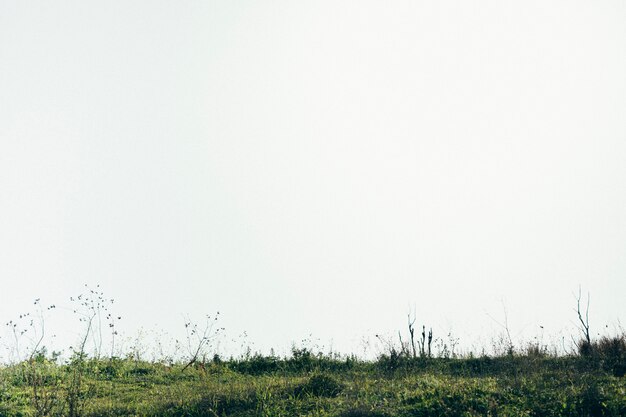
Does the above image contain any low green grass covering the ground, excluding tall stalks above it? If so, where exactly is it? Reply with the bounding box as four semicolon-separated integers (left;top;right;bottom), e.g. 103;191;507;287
0;348;626;417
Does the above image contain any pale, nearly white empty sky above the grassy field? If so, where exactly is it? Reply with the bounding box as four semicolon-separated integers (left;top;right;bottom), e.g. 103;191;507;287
0;0;626;358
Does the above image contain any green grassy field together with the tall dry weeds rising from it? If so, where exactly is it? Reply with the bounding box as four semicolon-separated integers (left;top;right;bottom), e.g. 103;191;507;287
0;290;626;417
